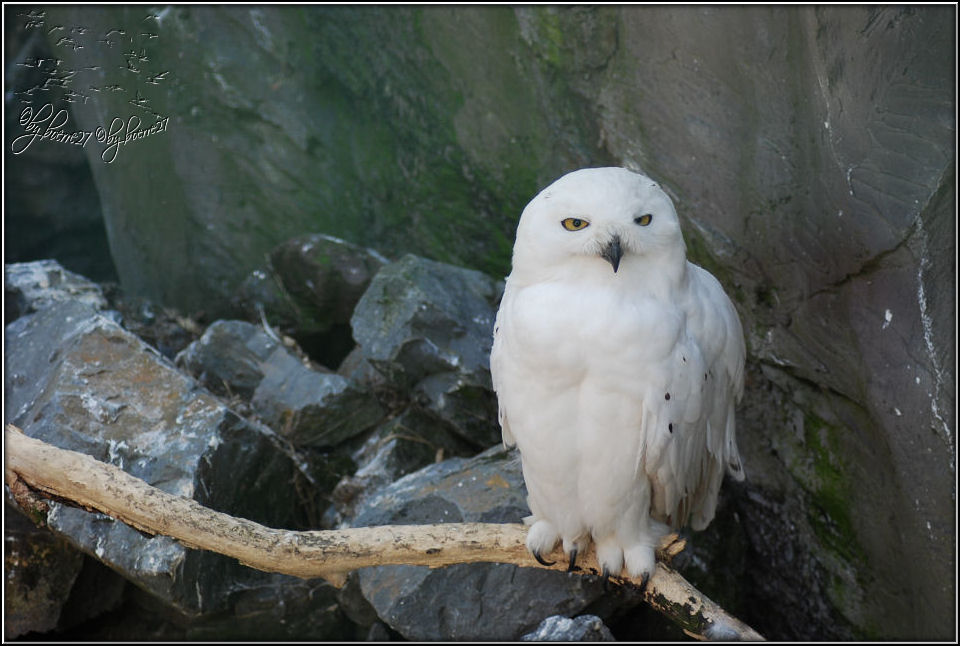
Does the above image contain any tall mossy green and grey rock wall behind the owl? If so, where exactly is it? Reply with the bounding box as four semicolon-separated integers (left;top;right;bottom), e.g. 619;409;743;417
8;6;956;639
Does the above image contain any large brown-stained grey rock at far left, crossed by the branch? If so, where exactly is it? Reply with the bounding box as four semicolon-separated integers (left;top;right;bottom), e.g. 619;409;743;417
5;301;312;615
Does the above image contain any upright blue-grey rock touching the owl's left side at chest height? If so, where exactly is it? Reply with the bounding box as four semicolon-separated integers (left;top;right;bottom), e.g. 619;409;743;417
351;254;500;448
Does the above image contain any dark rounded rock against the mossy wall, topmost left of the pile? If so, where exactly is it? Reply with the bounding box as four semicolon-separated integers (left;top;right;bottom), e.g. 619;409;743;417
234;234;387;368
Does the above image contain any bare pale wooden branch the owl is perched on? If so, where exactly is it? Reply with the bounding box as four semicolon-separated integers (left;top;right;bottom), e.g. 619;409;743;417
4;424;763;640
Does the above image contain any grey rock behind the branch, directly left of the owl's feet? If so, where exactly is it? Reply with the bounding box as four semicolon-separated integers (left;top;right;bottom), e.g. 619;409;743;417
352;447;624;641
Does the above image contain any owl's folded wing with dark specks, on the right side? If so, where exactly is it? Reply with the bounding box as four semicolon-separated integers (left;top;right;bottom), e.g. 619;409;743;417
638;263;745;529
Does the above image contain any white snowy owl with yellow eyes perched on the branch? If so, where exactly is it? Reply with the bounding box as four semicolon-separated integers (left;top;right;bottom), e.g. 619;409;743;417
490;168;744;580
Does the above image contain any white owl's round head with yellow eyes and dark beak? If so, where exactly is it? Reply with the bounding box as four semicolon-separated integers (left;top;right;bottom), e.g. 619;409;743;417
513;168;686;274
